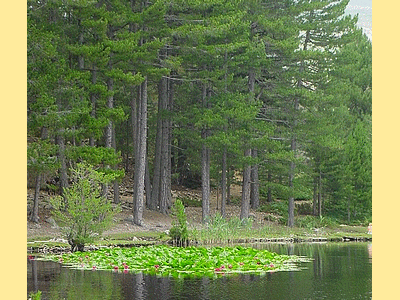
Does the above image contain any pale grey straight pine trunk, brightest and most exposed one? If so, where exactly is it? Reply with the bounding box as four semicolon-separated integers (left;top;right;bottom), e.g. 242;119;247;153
133;77;147;226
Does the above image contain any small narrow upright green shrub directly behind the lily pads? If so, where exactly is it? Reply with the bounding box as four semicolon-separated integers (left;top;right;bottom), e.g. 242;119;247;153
169;199;189;246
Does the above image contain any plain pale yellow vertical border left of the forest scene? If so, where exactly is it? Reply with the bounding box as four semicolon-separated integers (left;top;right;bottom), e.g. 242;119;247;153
0;1;27;299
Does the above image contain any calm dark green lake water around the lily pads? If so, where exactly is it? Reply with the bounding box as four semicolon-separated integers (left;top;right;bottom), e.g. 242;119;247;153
28;243;372;300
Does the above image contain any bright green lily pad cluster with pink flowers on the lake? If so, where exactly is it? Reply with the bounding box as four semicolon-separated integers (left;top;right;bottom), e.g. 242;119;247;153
44;245;301;277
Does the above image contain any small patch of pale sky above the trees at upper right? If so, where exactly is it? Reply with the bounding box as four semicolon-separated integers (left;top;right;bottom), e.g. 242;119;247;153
346;0;372;41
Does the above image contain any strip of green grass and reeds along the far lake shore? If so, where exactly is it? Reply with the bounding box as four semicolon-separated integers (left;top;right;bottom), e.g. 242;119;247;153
27;214;372;250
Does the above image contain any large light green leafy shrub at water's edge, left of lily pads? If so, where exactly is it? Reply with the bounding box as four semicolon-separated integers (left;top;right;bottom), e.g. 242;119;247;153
51;163;119;252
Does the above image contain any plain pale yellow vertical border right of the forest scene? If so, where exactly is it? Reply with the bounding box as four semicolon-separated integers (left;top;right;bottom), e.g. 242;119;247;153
372;0;400;300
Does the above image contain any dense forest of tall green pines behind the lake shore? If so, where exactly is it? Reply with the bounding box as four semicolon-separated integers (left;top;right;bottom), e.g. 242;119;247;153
27;0;372;227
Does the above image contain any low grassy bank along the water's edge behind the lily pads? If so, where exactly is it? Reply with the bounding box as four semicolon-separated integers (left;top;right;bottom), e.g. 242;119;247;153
27;223;372;253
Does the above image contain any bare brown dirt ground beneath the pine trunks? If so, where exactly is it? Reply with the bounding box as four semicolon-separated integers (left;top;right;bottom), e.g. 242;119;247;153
27;185;265;240
